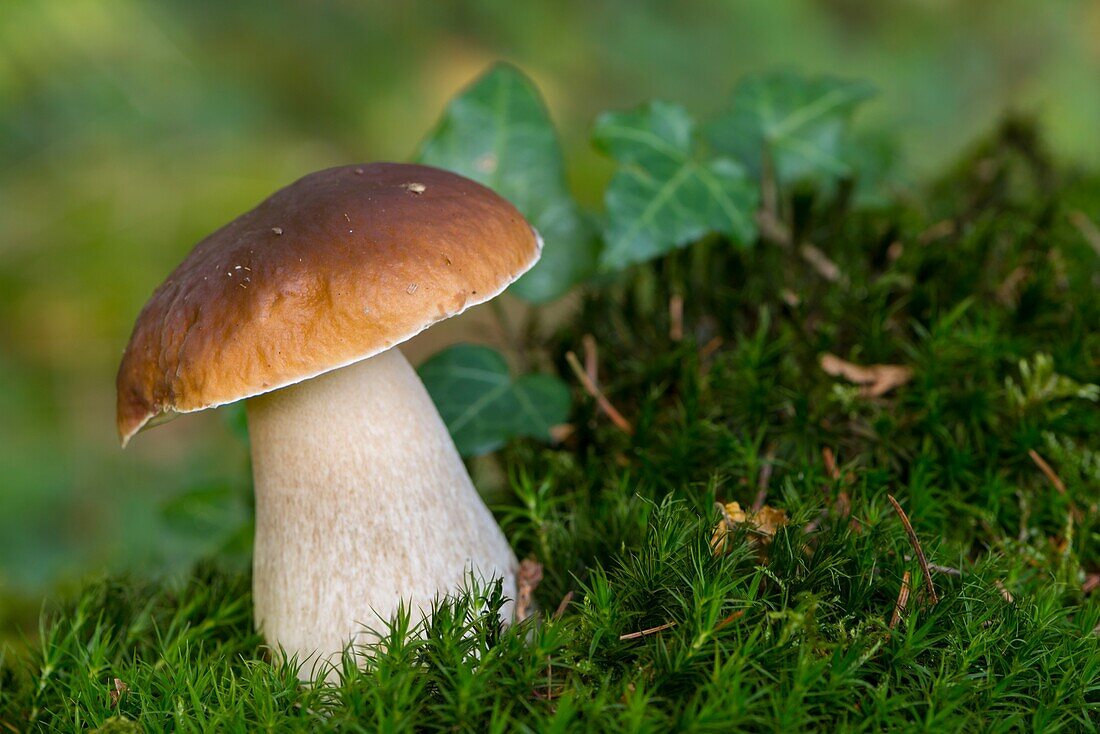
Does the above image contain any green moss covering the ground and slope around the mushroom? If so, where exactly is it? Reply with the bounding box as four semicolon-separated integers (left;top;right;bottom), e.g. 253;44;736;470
0;123;1100;732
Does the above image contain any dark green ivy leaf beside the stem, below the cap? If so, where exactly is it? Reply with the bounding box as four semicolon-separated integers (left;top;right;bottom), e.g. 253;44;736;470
419;344;571;457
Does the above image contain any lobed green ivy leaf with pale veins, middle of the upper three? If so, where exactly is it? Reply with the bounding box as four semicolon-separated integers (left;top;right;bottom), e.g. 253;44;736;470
593;102;757;270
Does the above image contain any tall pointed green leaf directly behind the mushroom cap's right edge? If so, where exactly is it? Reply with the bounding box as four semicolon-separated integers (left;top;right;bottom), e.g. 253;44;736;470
417;64;596;303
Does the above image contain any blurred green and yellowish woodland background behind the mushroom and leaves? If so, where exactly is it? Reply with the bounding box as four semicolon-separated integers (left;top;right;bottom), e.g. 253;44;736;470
0;0;1100;628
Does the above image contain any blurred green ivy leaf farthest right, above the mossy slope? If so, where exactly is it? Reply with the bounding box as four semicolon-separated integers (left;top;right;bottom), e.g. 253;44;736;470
707;72;875;185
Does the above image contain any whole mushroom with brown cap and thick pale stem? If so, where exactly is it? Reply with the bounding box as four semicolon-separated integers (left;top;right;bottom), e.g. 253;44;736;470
118;163;541;662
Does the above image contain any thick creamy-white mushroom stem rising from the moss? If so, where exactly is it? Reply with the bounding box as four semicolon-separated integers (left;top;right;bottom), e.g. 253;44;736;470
248;349;517;675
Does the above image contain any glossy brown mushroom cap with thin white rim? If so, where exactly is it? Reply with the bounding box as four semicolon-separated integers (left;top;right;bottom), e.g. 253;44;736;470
118;163;541;445
